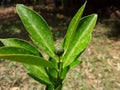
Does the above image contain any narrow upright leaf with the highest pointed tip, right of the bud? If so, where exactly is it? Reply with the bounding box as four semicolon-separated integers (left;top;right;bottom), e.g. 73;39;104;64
63;2;86;52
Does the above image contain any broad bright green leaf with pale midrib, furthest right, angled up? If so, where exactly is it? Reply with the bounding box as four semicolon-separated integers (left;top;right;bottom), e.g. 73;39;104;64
62;14;97;67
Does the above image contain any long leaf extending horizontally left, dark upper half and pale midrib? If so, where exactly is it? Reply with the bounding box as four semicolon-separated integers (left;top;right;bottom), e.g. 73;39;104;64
0;47;54;68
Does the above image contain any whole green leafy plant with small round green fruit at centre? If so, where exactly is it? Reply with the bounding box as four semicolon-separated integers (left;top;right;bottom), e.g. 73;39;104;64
0;2;97;90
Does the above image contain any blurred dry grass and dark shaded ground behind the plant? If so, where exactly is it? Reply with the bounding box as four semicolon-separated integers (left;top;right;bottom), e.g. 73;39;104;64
0;0;120;90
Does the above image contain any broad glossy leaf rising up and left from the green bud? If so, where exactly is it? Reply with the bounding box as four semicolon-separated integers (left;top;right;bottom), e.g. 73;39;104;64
16;4;58;61
